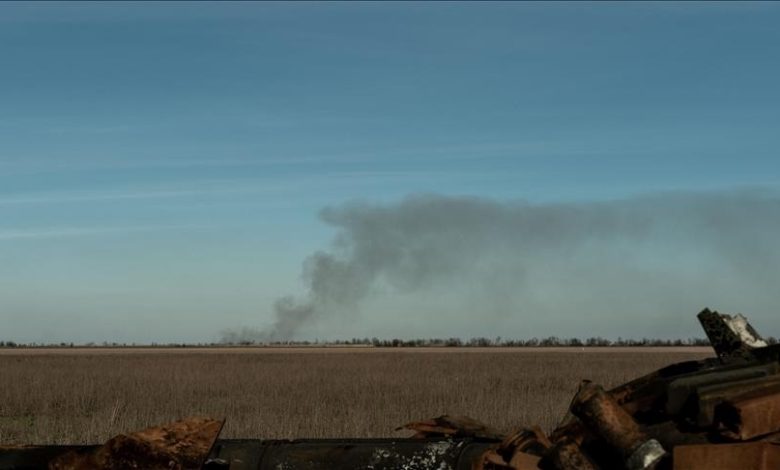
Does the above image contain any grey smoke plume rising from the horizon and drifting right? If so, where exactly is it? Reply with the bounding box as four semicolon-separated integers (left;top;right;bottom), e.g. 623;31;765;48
225;190;780;341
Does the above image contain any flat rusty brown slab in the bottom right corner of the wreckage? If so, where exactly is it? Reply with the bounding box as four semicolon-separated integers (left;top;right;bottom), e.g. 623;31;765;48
674;442;780;470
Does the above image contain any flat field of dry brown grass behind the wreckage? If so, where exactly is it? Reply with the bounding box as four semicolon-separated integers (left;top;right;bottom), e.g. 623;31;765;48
0;348;711;444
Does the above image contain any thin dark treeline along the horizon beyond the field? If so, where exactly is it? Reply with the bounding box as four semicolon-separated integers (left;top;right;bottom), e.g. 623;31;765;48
0;336;778;348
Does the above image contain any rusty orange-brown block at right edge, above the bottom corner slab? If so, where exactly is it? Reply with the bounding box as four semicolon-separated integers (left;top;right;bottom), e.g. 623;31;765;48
715;386;780;440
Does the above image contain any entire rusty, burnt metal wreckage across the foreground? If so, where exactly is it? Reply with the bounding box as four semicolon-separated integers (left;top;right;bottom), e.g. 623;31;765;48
0;310;780;470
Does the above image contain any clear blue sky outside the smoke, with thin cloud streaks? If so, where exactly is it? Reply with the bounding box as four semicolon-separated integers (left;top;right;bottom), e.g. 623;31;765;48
0;2;780;342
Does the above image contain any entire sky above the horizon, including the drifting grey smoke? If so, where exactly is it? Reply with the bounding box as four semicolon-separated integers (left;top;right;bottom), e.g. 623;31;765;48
0;2;780;343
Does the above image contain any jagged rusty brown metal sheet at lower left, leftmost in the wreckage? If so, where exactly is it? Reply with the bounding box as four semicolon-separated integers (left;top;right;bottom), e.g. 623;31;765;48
49;418;224;470
